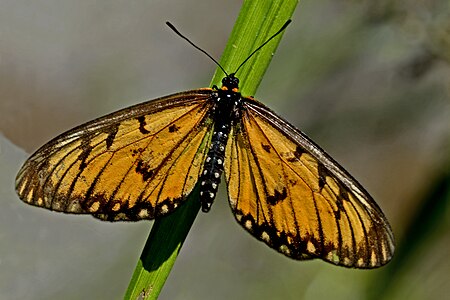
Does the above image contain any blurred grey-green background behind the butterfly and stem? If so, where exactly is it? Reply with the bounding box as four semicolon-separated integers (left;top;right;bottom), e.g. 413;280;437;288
0;0;450;300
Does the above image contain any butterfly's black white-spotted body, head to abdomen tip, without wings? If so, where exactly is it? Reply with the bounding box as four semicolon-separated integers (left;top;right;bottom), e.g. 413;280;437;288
200;74;242;212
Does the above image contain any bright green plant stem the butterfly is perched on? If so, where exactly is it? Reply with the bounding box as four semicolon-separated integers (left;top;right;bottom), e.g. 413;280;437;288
124;0;298;299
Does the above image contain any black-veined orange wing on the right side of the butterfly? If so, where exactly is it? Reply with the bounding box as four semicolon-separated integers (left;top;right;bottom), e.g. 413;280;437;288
225;98;394;268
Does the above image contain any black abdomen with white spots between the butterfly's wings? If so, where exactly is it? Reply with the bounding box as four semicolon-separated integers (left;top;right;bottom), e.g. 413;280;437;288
200;124;230;212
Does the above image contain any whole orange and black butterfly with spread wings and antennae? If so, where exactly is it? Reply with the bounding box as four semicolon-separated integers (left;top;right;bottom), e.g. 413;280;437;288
16;21;394;268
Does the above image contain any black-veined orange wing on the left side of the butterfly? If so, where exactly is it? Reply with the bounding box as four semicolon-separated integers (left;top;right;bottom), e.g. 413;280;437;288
16;89;212;221
